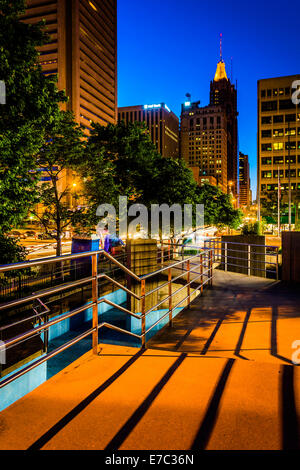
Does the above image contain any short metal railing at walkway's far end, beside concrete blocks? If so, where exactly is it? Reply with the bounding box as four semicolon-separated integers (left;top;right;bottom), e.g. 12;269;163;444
204;238;280;281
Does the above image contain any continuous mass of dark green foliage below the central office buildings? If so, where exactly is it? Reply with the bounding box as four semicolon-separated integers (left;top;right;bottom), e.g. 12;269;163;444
80;122;242;228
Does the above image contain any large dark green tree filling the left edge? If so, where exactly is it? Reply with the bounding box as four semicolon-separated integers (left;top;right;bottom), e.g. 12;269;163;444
0;0;66;236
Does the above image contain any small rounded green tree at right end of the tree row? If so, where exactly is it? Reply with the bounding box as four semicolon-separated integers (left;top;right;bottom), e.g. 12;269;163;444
196;184;243;229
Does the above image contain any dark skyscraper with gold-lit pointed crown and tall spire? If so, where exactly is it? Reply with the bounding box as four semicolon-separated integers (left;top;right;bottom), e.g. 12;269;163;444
210;36;238;197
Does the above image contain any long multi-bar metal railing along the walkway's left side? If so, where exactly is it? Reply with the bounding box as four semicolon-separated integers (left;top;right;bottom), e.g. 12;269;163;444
0;247;213;389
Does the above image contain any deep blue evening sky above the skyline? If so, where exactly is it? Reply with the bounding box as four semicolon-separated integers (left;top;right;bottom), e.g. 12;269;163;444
118;0;300;197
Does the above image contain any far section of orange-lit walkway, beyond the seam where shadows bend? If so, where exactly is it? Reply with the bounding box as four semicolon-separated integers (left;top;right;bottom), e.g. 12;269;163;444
148;270;300;364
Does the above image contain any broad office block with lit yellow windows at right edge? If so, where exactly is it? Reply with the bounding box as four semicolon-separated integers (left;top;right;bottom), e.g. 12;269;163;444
257;75;300;223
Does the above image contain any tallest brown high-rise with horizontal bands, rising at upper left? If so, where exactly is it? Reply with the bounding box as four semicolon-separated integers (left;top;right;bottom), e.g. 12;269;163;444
23;0;117;129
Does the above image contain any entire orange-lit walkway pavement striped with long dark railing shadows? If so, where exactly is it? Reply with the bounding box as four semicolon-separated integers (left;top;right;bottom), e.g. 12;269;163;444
0;273;300;450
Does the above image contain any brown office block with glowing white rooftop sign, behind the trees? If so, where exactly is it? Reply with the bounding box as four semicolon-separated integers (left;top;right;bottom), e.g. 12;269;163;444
118;103;179;158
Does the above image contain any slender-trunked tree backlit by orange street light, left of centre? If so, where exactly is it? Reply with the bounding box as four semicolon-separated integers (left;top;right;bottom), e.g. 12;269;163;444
32;111;84;256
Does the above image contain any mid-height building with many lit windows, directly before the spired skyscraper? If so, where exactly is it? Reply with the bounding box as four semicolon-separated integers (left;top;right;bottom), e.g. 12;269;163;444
180;101;227;192
